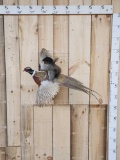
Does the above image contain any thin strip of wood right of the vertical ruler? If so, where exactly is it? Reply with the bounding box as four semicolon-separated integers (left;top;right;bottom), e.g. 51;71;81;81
116;45;120;160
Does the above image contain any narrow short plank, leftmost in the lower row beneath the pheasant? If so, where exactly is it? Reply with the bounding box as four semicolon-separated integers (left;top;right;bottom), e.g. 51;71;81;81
21;105;34;160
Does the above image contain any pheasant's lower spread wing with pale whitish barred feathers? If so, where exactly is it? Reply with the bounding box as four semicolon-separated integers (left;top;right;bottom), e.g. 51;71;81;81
36;80;60;104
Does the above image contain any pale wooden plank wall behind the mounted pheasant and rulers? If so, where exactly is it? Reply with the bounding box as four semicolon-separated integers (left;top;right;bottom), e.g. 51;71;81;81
0;0;120;160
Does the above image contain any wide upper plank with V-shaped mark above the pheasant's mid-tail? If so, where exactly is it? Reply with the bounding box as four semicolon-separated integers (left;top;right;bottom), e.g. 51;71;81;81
69;15;91;104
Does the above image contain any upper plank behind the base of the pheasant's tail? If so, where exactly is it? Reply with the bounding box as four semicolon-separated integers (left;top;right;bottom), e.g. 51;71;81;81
53;0;68;104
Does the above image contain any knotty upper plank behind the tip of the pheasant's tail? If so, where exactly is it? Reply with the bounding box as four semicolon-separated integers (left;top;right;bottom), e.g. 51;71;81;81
90;15;111;104
